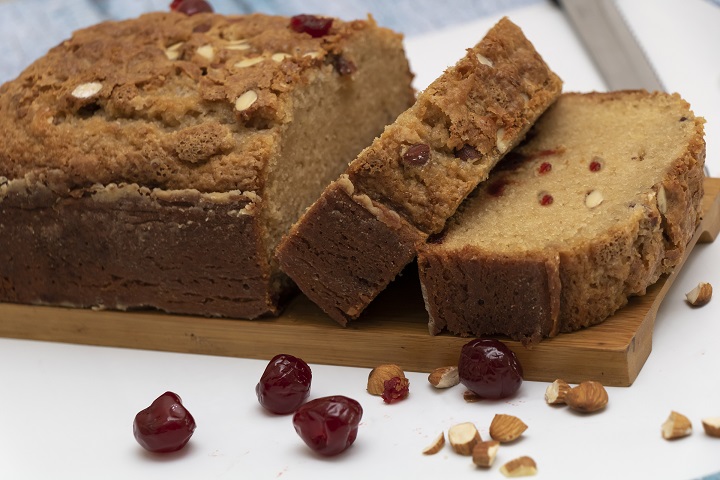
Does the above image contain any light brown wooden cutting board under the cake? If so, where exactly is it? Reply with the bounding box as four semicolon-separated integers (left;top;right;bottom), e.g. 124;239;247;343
0;178;720;386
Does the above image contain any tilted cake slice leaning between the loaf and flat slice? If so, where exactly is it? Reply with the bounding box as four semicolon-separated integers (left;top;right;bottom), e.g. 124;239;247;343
277;18;562;325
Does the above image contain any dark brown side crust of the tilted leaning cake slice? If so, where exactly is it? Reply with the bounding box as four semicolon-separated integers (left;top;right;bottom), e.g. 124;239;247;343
278;183;424;326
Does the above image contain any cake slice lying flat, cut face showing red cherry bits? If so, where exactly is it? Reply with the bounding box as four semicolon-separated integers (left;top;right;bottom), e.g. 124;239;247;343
418;91;705;343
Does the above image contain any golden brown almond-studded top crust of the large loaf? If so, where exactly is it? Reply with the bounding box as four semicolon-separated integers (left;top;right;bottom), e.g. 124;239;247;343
0;12;398;192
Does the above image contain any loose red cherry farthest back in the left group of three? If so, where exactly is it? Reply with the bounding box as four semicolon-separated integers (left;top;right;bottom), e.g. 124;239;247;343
255;354;312;415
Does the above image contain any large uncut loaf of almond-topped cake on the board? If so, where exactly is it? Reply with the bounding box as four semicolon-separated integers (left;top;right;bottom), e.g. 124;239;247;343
0;12;415;318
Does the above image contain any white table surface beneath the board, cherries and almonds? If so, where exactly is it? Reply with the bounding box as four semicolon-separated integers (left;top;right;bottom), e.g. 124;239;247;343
0;4;720;480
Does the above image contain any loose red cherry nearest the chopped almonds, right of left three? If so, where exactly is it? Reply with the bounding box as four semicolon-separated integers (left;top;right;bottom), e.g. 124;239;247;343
293;395;363;456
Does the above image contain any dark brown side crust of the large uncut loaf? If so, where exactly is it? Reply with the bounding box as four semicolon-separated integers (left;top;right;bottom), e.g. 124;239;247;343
0;180;280;318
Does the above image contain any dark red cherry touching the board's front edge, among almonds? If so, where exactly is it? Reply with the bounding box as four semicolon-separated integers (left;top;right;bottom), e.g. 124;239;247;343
458;339;523;399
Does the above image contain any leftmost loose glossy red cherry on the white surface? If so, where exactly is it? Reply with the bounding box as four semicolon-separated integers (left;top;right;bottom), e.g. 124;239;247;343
133;392;195;453
